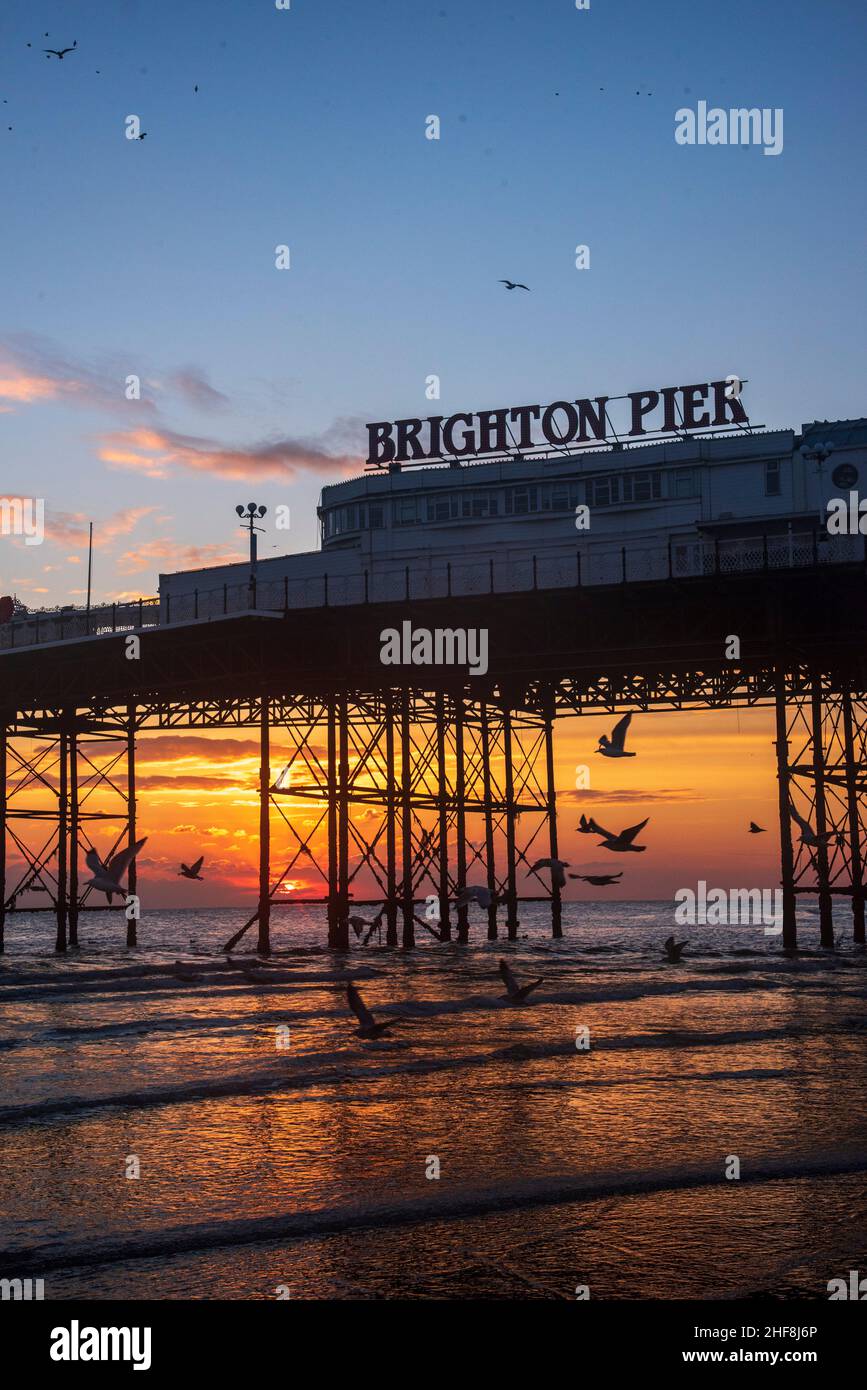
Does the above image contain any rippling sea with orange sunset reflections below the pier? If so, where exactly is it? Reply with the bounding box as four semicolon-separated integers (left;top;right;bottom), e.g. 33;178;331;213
0;902;867;1300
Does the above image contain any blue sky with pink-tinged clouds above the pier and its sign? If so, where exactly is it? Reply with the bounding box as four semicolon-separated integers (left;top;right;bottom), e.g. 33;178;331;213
0;0;867;605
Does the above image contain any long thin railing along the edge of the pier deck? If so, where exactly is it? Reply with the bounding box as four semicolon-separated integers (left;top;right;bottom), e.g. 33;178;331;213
0;531;867;651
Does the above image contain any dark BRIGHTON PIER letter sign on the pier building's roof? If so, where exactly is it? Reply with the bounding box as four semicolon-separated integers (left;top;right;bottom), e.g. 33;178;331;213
367;377;749;470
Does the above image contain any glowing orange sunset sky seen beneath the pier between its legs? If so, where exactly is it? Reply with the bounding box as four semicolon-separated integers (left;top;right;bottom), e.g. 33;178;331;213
10;709;779;909
